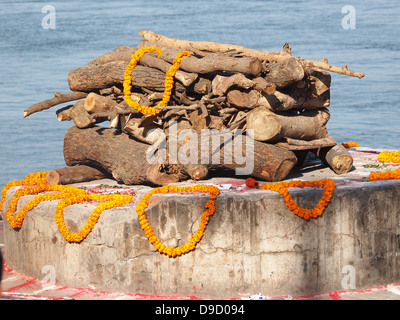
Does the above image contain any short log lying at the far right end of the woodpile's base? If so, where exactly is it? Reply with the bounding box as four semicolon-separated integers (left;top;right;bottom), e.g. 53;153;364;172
314;143;353;174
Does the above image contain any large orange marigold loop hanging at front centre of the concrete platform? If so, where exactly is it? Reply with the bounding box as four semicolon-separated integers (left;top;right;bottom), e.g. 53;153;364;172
136;185;219;257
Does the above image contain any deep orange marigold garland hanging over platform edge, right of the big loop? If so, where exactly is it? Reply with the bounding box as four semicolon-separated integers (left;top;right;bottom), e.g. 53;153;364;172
261;179;336;220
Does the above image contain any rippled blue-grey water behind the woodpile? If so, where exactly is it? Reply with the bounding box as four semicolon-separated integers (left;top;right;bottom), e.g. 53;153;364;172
0;0;400;188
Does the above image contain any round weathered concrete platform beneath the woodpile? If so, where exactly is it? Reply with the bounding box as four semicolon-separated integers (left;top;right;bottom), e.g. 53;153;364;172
3;148;400;299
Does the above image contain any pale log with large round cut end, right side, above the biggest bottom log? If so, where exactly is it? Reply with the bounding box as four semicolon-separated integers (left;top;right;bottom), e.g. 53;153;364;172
246;107;330;142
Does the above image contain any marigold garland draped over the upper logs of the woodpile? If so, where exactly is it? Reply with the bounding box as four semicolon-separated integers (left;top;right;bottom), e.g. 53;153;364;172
124;46;190;115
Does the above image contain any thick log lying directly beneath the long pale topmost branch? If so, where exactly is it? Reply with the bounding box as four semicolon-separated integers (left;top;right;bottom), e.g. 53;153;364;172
138;41;262;76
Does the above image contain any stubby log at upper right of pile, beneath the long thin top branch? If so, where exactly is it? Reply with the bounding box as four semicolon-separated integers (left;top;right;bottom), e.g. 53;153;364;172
265;58;304;89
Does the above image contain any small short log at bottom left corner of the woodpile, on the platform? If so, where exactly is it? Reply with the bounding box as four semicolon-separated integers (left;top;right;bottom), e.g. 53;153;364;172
46;165;109;185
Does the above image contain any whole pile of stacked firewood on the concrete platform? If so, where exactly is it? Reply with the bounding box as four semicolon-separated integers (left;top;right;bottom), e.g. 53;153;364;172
24;31;364;185
